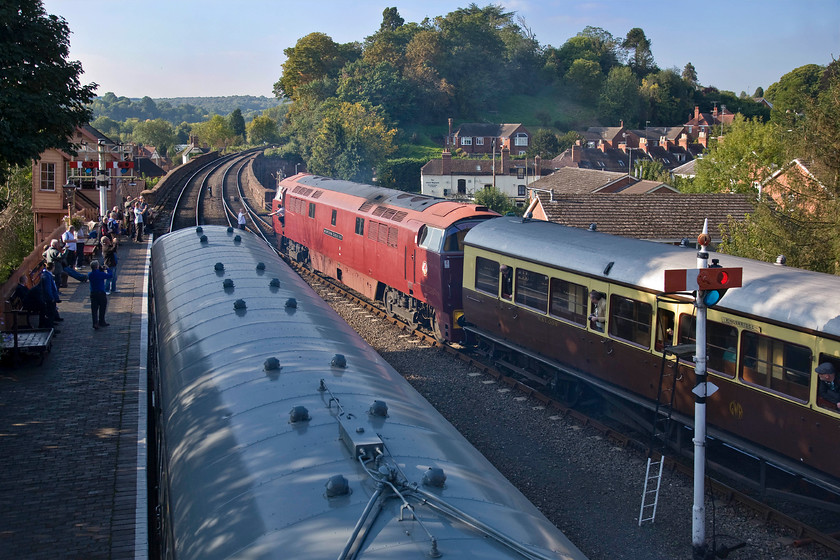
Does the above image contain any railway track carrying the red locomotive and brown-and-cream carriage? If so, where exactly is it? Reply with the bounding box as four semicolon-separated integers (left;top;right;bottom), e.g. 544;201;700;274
164;162;840;553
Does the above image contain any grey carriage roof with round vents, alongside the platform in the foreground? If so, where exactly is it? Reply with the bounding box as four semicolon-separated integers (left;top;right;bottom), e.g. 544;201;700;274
152;226;584;560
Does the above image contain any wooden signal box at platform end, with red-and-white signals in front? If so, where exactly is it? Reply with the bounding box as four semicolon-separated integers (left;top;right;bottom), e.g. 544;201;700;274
32;125;136;247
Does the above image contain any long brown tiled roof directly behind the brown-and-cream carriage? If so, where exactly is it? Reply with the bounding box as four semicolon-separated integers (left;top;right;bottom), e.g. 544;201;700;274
537;192;753;242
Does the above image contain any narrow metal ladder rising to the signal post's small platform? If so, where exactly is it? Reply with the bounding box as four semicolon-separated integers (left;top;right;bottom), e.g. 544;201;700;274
639;344;694;527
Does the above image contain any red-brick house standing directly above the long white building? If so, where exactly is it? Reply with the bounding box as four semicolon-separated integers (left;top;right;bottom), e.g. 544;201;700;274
444;119;531;156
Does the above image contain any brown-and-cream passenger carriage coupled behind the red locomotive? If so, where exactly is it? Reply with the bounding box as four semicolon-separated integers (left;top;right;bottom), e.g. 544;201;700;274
463;217;840;491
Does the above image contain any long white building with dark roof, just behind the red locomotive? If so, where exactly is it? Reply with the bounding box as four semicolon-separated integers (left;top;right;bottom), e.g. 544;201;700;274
420;148;547;205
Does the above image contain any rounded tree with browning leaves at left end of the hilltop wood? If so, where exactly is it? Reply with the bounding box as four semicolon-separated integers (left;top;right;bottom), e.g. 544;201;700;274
274;32;361;99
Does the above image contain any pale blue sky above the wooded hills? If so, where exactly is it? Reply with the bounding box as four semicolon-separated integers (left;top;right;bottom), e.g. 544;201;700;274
43;0;840;98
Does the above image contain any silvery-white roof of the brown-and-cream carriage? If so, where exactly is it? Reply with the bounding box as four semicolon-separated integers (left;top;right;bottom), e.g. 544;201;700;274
465;217;840;337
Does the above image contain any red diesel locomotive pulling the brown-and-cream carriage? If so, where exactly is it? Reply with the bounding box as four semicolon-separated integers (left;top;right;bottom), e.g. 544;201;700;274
273;173;498;340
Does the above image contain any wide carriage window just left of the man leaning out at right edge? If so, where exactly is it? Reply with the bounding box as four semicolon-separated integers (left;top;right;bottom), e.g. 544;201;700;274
741;331;811;401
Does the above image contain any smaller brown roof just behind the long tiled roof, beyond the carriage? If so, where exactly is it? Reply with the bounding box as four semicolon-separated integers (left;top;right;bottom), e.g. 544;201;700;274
530;167;677;194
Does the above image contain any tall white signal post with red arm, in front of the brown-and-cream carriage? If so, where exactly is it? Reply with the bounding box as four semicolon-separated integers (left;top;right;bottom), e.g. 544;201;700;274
639;220;743;560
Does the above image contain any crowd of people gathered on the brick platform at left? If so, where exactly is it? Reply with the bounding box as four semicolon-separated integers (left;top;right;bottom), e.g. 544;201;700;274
12;196;153;334
